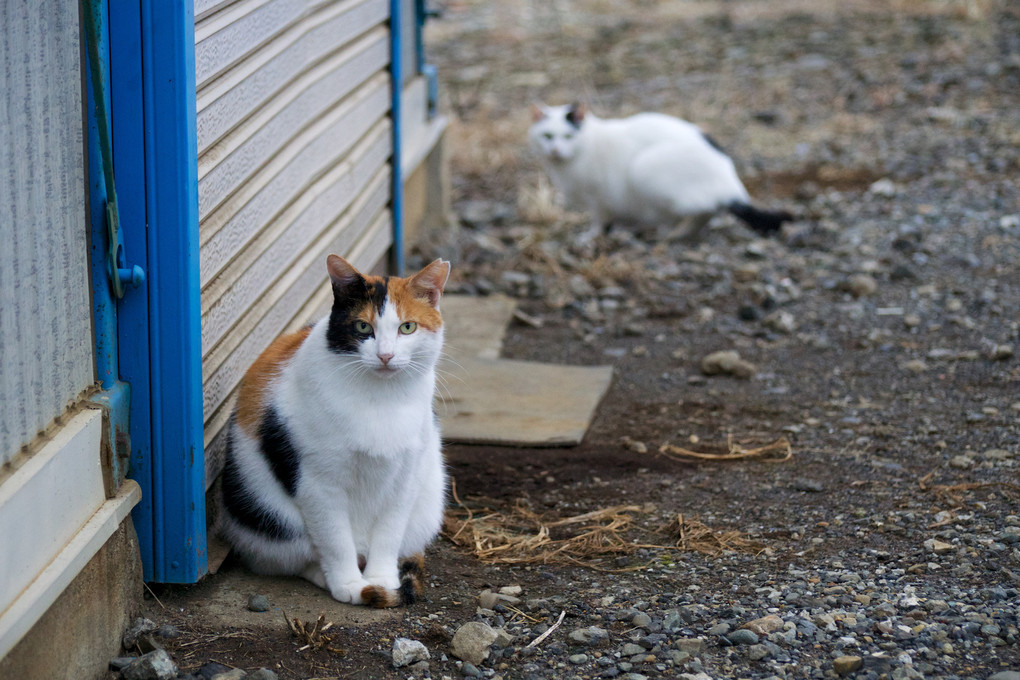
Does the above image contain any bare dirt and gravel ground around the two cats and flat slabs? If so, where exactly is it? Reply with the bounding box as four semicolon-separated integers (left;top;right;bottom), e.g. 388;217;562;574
139;0;1020;680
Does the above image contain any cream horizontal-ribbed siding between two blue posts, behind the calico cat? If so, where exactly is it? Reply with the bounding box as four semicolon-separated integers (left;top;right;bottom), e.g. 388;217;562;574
195;0;392;483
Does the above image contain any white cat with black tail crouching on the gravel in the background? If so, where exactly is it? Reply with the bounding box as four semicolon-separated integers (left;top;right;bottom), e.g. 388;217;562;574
528;104;793;238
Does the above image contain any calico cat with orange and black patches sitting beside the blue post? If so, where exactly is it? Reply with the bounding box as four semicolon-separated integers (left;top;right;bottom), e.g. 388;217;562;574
218;255;450;607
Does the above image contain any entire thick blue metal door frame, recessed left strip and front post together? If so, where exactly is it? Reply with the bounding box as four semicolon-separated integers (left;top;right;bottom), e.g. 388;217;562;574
105;0;206;583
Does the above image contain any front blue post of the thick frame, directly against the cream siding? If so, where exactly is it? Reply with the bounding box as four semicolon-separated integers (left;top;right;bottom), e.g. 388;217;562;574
142;0;206;583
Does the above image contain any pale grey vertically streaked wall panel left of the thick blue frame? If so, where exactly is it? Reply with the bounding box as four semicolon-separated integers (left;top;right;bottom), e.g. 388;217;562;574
0;0;95;464
